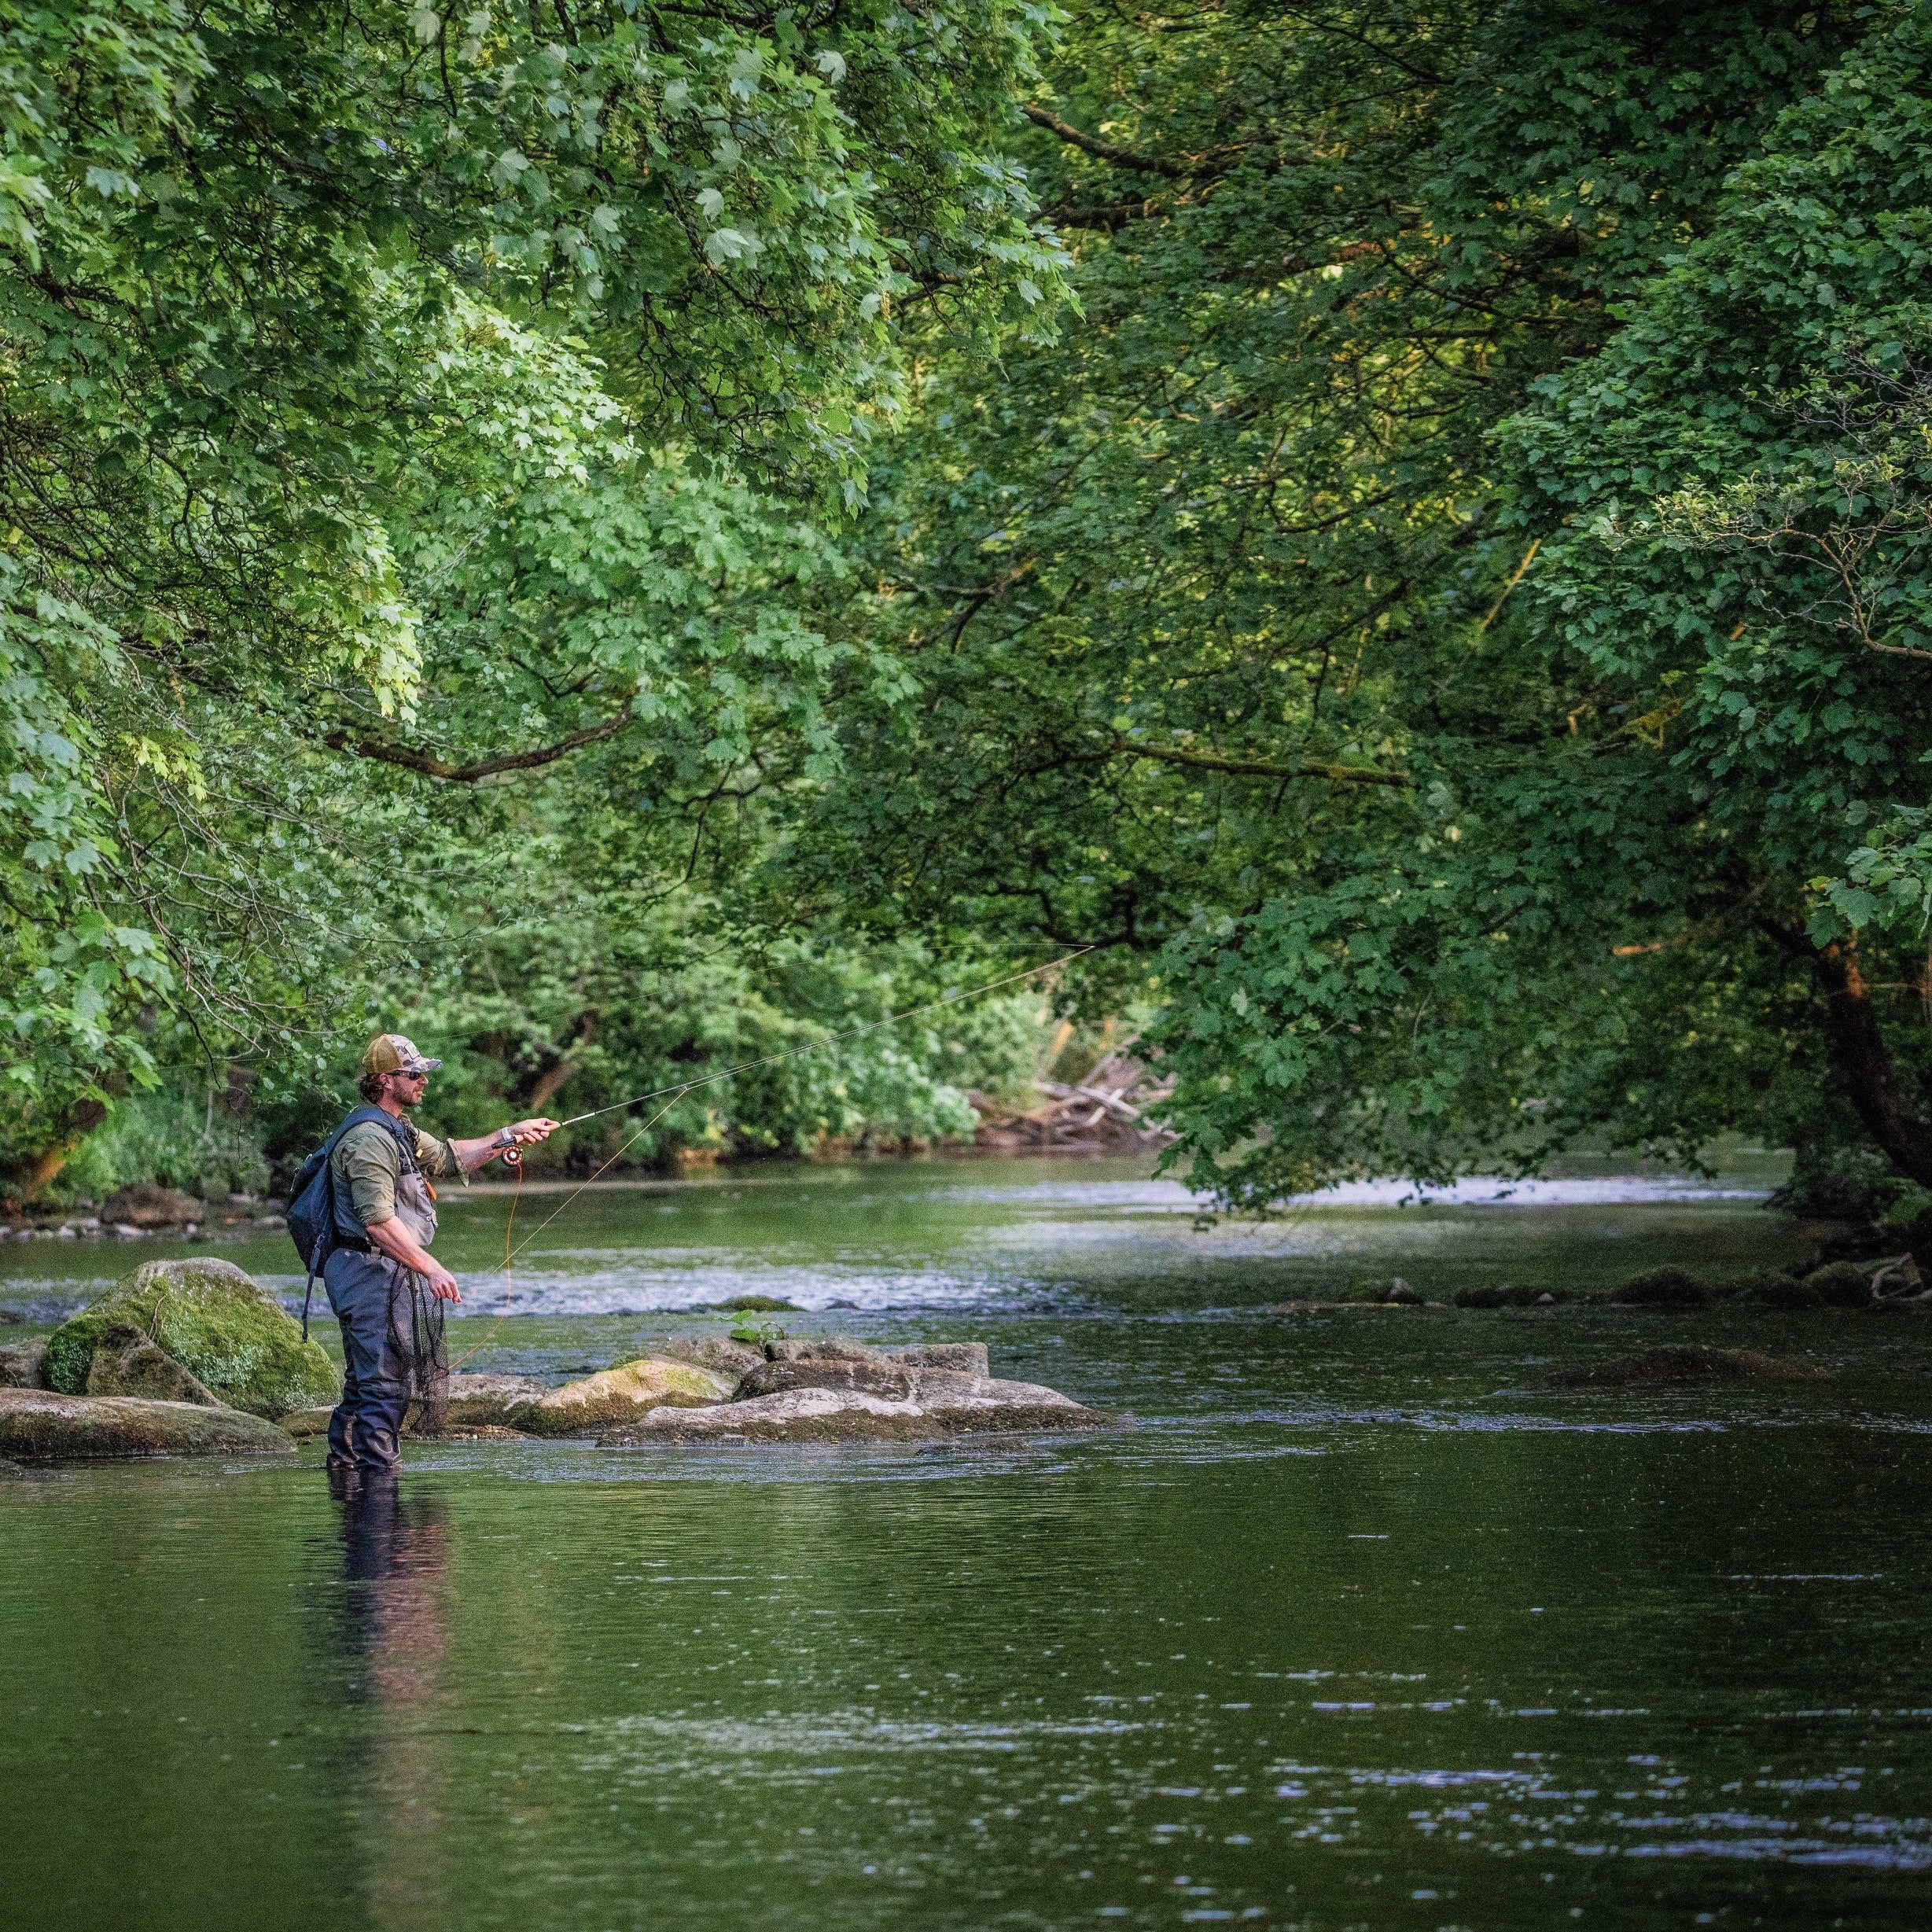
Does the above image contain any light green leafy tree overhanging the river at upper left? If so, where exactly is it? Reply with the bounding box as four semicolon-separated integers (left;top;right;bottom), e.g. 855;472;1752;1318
0;0;1055;1180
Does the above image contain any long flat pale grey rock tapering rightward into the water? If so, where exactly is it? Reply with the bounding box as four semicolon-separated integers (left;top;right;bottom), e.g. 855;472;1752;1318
599;1362;1109;1449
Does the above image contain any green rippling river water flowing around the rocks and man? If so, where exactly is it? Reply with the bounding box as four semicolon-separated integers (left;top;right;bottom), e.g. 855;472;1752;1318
0;1161;1932;1932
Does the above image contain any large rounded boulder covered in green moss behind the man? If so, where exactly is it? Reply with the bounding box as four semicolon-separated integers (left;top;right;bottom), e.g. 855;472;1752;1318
46;1258;338;1422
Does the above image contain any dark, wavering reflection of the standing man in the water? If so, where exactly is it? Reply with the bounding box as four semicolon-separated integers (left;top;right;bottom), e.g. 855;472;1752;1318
329;1468;450;1932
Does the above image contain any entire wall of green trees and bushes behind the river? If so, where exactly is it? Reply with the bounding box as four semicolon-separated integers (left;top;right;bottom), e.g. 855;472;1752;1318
0;0;1932;1244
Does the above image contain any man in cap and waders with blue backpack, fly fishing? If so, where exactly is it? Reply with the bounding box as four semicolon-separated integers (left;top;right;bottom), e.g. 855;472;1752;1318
288;1033;558;1470
